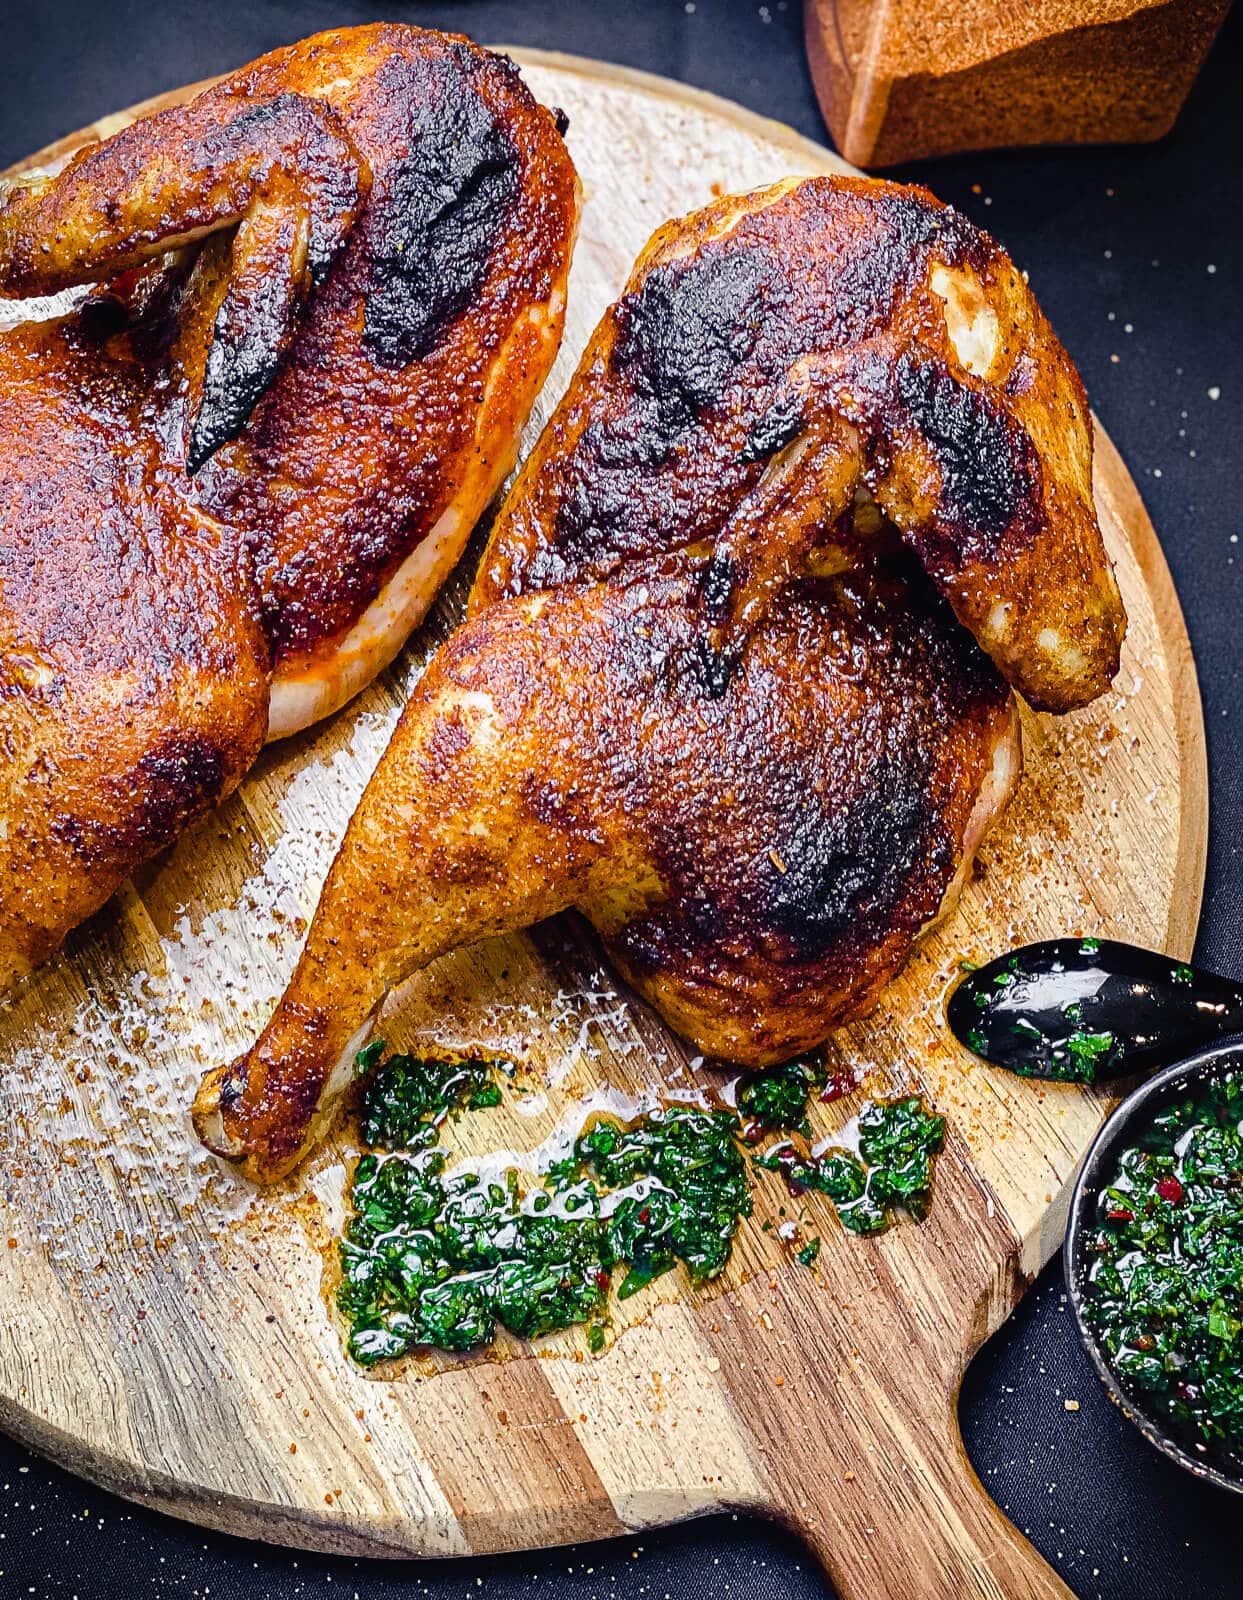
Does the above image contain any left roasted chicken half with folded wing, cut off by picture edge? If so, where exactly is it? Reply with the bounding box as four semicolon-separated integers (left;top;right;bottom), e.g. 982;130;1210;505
0;26;578;992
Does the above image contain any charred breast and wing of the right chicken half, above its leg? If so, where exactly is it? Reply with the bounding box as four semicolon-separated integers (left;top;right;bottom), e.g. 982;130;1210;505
475;178;1126;710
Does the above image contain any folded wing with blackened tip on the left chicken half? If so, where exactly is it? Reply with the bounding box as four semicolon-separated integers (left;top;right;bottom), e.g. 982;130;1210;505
0;93;371;472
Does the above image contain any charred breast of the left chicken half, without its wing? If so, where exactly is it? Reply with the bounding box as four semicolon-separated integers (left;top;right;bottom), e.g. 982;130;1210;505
185;27;578;722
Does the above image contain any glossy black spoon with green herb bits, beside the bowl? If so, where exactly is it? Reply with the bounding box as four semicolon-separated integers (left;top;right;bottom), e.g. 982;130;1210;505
945;939;1243;1083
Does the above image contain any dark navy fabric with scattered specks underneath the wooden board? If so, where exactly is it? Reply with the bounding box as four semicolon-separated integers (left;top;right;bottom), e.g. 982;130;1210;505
0;0;1243;1600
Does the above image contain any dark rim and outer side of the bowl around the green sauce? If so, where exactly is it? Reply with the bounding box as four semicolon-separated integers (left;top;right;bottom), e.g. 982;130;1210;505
1062;1042;1243;1494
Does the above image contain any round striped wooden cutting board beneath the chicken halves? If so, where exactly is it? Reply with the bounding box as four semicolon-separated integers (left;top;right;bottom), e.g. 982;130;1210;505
0;51;1206;1600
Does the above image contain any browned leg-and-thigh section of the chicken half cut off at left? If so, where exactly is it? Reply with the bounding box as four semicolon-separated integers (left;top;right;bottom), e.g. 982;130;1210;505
0;318;269;992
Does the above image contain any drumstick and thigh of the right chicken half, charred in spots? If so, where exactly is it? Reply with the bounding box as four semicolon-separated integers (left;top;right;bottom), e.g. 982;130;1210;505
195;557;1017;1182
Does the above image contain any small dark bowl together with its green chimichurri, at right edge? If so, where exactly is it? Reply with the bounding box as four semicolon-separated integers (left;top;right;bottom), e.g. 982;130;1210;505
1065;1045;1243;1493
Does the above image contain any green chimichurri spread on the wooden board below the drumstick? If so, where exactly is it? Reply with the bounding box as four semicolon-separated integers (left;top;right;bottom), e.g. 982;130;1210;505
338;1045;945;1366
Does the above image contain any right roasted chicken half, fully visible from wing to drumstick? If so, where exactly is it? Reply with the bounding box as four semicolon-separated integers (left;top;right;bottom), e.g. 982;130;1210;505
195;179;1125;1181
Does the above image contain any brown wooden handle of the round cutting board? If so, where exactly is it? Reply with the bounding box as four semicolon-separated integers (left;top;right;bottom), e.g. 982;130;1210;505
764;1402;1075;1600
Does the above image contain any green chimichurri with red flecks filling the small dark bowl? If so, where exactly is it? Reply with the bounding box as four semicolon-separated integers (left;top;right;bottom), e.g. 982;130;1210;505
1085;1072;1243;1464
